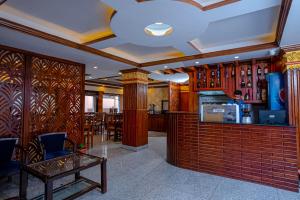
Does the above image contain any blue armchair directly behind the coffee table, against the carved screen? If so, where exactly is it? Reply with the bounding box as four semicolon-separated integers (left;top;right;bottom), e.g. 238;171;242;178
38;132;76;160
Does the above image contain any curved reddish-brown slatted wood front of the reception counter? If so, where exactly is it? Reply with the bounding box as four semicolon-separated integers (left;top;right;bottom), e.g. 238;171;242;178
167;112;298;191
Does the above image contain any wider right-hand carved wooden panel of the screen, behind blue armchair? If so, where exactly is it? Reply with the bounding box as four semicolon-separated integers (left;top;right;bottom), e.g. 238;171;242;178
29;57;83;143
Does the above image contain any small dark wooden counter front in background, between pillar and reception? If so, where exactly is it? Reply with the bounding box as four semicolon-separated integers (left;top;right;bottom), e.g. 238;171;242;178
148;114;167;132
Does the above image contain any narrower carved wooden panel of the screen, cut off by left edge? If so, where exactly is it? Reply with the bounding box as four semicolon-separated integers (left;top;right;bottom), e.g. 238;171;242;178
0;49;25;137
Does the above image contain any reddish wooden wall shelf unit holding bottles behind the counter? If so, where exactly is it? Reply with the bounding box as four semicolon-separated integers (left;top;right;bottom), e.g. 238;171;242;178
194;59;273;104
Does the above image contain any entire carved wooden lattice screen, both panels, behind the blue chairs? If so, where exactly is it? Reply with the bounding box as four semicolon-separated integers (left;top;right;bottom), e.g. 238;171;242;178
0;46;84;145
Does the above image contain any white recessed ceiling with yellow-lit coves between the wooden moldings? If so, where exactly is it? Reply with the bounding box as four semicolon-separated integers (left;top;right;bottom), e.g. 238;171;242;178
0;0;300;81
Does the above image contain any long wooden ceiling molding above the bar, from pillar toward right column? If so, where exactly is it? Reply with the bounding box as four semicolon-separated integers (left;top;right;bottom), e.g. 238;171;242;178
139;42;278;67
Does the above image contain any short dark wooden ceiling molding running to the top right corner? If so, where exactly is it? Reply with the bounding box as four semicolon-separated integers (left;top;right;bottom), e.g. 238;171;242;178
276;0;293;44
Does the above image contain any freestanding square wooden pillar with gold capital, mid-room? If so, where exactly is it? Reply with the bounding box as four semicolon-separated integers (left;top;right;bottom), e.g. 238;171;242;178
122;69;149;151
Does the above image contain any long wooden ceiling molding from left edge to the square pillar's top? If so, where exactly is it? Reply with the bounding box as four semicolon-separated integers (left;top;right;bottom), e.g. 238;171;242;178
0;18;138;66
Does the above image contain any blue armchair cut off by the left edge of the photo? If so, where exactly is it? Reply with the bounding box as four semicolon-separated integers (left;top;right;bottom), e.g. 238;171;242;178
0;138;20;177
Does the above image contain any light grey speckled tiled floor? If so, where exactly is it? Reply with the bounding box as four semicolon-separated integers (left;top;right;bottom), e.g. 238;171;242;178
0;134;300;200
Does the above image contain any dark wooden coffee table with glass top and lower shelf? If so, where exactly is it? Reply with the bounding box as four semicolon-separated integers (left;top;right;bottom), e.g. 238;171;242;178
20;152;107;200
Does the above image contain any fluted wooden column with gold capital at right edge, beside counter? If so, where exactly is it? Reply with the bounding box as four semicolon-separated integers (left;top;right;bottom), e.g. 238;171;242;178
284;50;300;167
